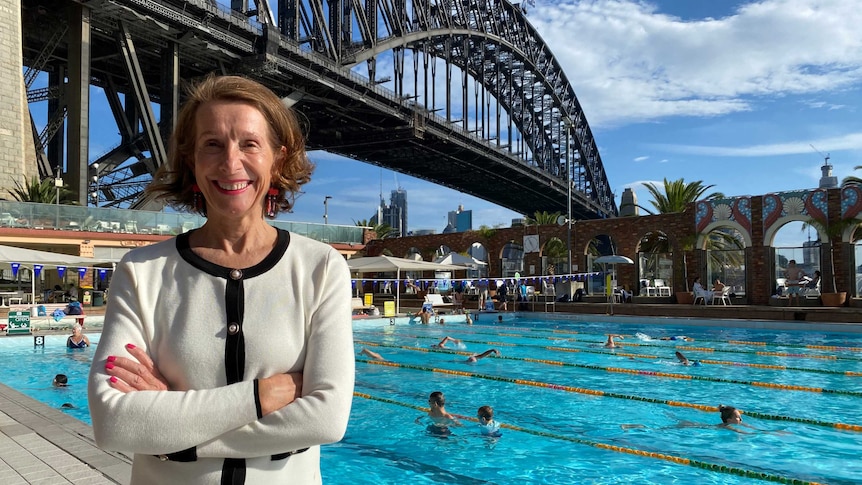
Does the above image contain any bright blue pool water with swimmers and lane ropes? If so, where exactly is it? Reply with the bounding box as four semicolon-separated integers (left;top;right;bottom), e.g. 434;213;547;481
0;315;862;485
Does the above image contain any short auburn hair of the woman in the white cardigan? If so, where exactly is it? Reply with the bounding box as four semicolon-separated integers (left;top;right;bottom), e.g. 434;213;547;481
145;74;314;215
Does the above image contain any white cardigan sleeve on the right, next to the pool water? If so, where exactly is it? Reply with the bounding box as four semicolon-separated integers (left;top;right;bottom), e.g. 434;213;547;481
197;250;356;458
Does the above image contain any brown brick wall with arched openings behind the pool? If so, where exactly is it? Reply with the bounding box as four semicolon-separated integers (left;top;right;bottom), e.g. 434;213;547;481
366;189;862;305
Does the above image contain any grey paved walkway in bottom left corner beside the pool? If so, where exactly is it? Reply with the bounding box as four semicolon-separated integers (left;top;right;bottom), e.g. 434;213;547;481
0;384;132;485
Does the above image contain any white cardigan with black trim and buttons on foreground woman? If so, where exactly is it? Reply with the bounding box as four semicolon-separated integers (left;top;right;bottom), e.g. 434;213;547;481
89;230;354;484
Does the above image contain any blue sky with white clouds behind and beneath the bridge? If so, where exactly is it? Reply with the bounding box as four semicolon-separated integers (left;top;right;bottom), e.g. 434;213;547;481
44;0;862;238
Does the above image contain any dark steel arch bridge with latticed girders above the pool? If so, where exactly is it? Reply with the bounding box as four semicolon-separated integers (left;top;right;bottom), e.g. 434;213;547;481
22;0;617;218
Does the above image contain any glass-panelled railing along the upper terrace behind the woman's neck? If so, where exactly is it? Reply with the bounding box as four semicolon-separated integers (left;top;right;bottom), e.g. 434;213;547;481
0;201;364;244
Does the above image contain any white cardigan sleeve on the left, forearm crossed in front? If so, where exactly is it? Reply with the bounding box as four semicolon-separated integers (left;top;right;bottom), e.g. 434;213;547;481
88;260;258;455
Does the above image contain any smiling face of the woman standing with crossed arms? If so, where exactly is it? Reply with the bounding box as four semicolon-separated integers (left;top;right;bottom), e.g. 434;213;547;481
194;101;279;225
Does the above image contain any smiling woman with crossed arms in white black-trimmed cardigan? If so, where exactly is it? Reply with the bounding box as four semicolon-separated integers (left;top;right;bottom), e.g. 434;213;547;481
88;76;354;484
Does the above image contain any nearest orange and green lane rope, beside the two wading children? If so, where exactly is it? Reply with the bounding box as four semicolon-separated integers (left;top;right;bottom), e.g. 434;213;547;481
353;390;821;485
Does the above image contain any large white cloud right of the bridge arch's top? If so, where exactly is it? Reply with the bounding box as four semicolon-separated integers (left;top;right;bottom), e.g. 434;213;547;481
530;0;862;126
